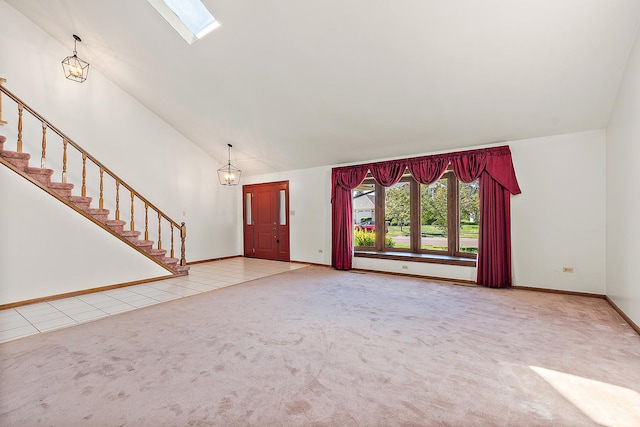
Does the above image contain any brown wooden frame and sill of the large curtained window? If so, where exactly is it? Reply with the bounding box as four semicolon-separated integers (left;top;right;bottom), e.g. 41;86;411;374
354;169;477;266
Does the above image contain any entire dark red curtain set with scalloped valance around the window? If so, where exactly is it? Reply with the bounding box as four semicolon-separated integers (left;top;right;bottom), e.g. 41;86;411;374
332;146;520;287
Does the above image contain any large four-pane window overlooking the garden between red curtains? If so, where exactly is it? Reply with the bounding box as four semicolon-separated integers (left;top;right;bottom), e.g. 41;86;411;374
352;170;480;261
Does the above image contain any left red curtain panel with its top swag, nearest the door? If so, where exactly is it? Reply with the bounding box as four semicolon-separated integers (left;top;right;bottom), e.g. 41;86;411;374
331;165;369;270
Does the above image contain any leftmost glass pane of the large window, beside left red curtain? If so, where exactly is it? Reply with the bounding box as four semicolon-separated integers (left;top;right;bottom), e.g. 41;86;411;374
352;183;376;247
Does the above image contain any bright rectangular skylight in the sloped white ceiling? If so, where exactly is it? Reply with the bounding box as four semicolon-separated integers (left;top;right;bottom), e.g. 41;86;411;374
147;0;220;44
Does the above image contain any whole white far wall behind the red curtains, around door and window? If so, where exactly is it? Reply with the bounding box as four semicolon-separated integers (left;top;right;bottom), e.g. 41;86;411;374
245;131;605;294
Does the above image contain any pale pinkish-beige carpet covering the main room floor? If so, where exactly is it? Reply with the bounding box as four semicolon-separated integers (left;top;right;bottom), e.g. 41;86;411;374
0;266;640;426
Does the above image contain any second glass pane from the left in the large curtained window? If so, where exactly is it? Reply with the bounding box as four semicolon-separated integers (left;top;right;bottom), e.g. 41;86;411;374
384;182;411;249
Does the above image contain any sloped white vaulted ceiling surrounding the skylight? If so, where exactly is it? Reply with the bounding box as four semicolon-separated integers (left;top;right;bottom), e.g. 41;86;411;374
7;0;640;174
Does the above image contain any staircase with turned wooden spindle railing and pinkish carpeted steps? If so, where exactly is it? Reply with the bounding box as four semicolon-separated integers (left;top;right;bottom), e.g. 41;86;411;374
0;79;189;275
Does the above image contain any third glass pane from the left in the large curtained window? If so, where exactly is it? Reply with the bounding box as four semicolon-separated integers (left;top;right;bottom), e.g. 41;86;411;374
420;178;449;251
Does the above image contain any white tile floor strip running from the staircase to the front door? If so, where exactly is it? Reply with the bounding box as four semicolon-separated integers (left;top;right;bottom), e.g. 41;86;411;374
0;257;306;343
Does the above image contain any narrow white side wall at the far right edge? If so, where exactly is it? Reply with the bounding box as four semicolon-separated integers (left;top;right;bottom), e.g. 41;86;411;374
607;26;640;325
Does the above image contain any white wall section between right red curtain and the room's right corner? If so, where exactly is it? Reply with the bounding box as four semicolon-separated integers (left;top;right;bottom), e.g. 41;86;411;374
510;130;606;295
